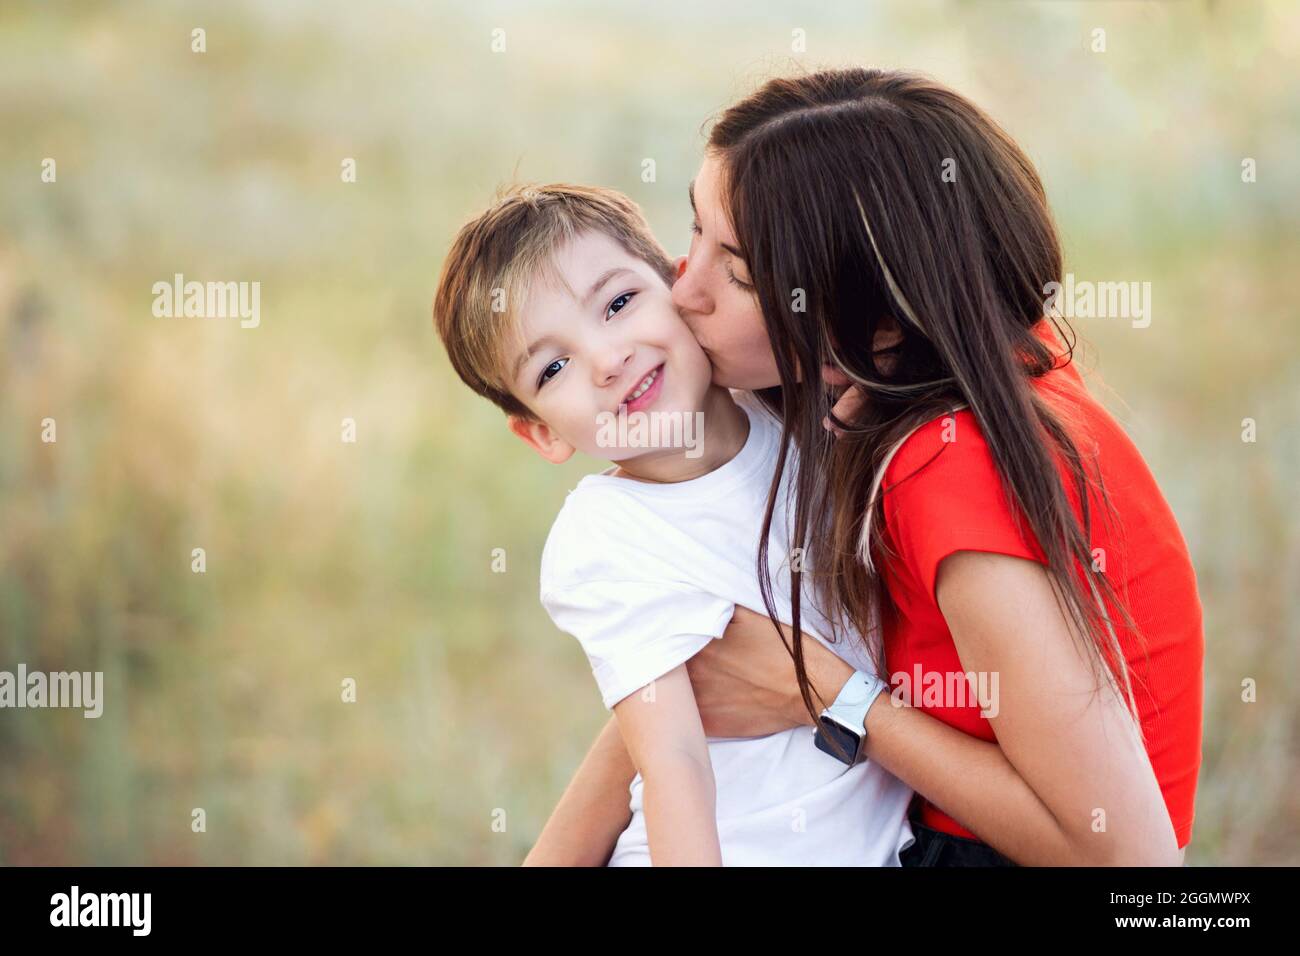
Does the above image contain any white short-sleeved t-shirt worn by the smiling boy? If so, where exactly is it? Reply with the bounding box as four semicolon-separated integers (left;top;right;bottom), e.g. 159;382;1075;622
541;392;913;866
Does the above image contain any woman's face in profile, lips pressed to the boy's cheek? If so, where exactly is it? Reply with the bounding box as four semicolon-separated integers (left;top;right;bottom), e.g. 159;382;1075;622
672;156;781;390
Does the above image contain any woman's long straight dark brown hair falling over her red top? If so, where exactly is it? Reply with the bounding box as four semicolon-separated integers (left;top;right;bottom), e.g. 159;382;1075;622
709;69;1134;754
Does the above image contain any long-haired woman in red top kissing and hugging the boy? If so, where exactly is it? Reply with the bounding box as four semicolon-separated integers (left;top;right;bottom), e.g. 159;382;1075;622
527;70;1204;865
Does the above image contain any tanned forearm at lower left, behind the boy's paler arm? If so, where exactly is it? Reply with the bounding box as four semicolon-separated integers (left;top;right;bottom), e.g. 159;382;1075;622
524;717;637;866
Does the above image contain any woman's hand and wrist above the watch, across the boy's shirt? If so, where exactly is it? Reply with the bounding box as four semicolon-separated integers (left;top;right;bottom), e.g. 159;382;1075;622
686;605;853;737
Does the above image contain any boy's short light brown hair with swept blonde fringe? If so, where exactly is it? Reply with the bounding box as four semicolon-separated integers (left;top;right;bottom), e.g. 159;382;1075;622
433;183;672;419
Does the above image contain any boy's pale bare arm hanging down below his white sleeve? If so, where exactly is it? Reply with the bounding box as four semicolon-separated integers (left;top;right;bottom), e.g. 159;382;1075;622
614;663;722;866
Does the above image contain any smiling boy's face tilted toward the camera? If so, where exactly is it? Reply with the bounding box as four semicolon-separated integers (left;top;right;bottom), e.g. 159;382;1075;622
506;232;712;462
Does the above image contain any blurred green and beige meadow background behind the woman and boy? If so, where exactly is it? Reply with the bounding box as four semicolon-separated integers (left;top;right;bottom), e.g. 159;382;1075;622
0;0;1300;865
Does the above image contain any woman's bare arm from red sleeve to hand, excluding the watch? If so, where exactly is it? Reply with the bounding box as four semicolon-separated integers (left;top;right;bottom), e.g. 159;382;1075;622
707;551;1180;865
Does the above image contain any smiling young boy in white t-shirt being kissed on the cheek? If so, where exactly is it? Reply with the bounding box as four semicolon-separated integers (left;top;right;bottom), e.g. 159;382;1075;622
434;186;911;866
